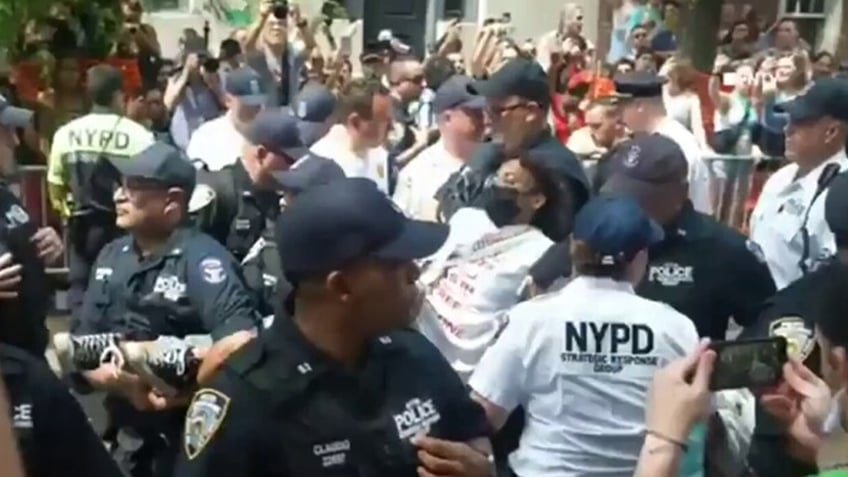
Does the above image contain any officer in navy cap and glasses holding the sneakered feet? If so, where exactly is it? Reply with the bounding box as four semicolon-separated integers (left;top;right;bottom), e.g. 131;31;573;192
59;143;259;476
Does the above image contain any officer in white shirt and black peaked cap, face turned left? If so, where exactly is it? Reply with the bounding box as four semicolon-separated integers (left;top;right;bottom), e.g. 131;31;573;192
615;72;713;214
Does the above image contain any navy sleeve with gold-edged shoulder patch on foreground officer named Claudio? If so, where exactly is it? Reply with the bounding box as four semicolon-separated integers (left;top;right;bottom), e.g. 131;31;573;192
174;370;279;477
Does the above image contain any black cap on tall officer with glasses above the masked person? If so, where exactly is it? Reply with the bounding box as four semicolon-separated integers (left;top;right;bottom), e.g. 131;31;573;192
473;58;551;107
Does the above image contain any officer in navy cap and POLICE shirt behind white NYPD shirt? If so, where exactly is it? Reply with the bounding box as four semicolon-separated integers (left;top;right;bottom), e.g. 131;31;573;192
601;134;775;340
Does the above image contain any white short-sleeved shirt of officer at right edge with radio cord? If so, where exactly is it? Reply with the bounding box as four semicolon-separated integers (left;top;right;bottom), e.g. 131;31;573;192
750;151;848;290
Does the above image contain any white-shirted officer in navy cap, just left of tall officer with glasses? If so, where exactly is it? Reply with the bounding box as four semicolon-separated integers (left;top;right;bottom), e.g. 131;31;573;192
394;75;486;222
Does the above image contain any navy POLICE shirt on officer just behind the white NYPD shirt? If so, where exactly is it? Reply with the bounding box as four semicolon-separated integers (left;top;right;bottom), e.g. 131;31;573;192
636;202;775;340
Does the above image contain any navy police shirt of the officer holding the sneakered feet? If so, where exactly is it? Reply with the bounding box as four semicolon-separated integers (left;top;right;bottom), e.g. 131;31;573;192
72;227;260;340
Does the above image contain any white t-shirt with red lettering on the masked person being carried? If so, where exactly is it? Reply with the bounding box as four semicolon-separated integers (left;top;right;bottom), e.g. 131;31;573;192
418;209;553;381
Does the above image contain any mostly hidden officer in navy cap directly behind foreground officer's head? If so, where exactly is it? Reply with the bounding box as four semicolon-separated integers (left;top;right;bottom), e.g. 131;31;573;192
241;156;345;324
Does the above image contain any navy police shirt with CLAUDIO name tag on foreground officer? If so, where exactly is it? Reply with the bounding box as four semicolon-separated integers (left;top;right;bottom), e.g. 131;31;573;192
174;312;489;477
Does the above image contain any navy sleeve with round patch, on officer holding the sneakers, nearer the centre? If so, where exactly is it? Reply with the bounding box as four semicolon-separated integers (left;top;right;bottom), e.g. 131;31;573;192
186;244;262;341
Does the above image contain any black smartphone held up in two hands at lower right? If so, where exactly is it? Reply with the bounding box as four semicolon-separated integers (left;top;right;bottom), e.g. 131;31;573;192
710;336;787;391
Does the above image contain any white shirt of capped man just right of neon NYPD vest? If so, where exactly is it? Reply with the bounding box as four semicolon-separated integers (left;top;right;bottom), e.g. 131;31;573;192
186;113;245;171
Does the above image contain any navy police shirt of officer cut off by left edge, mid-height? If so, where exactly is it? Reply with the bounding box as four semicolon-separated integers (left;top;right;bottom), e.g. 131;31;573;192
0;182;50;356
